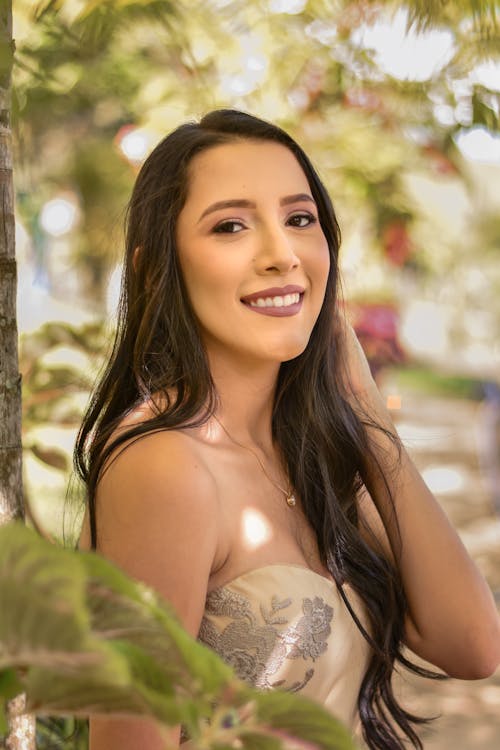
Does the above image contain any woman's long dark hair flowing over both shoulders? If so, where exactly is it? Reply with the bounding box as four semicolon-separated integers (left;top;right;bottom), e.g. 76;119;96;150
75;110;438;750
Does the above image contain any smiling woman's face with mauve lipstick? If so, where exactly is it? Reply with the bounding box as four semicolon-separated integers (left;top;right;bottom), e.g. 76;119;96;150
176;140;330;365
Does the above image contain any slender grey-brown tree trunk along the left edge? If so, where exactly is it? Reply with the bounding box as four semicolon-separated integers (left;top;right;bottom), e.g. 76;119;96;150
0;0;36;750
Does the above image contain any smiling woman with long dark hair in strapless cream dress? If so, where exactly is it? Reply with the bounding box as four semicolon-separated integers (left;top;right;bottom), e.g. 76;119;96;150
76;110;500;750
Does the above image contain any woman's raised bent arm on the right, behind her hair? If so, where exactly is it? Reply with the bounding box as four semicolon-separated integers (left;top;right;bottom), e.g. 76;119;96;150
346;329;500;679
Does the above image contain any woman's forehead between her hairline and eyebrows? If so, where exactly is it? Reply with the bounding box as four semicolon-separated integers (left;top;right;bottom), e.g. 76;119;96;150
187;140;310;202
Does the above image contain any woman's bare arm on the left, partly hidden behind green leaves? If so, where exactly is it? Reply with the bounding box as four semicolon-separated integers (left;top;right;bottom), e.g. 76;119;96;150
81;432;219;750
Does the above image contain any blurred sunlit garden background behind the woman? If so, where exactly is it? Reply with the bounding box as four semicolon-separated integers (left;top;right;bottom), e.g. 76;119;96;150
13;0;500;750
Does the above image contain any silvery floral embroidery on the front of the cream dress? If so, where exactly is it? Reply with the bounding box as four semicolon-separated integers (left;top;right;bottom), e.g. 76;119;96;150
198;587;333;692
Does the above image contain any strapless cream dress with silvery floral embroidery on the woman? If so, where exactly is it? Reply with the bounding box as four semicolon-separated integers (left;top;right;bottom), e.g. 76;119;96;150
198;564;370;731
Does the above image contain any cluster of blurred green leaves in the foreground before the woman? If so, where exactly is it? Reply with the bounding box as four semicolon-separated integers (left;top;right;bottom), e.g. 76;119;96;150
0;523;360;750
